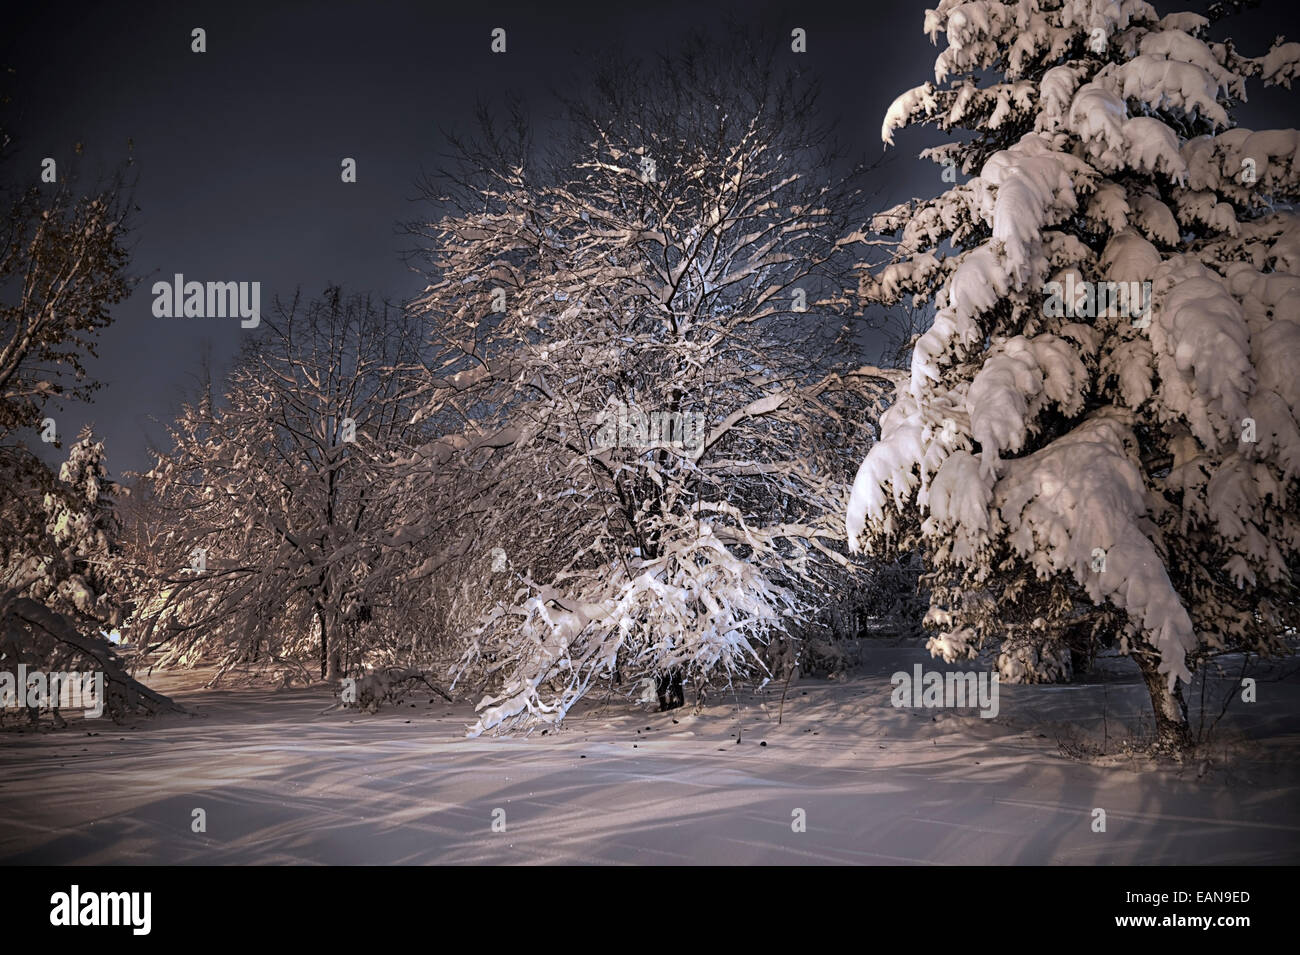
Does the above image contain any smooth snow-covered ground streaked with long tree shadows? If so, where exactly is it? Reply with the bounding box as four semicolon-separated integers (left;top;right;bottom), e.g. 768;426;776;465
0;647;1300;865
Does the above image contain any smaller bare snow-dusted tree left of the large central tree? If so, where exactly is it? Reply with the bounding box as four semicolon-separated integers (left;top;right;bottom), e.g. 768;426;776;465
139;288;428;678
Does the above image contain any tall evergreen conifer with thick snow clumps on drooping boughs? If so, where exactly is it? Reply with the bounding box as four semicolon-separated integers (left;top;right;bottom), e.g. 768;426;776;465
848;0;1300;750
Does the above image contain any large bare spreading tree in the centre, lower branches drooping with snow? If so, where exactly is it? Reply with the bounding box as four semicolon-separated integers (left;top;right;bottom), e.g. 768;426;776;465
417;39;894;732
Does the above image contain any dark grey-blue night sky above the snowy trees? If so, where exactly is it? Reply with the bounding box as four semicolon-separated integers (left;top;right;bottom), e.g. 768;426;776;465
0;0;1300;473
